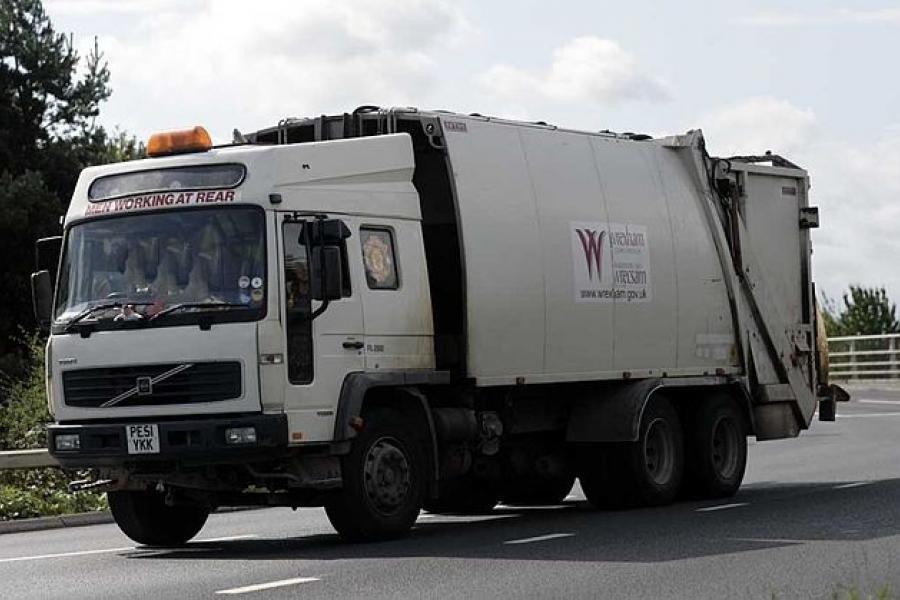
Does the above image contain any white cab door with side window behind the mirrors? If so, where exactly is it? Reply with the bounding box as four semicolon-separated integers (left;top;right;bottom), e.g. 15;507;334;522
279;213;364;442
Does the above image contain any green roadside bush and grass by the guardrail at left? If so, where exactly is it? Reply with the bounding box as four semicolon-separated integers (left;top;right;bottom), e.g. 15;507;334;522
0;335;106;521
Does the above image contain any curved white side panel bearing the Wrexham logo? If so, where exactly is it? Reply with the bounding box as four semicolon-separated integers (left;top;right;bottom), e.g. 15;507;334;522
448;120;739;385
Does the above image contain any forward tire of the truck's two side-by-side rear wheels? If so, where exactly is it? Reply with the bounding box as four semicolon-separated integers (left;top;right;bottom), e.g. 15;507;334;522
579;397;684;509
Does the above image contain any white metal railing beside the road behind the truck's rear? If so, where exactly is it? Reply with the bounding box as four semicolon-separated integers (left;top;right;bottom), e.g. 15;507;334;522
828;333;900;381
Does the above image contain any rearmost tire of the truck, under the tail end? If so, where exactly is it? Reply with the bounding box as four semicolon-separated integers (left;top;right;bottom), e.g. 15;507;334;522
684;396;747;499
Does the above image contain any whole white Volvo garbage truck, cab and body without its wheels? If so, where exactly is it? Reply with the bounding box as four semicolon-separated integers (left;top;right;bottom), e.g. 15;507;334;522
38;110;826;537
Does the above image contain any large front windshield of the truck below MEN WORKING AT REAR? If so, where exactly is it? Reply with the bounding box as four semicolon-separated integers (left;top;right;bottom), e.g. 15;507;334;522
54;207;266;325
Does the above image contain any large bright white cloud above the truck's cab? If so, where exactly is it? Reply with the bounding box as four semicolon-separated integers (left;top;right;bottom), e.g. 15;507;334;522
70;0;473;141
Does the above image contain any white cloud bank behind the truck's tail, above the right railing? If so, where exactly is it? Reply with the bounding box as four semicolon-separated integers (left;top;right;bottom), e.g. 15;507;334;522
697;97;900;301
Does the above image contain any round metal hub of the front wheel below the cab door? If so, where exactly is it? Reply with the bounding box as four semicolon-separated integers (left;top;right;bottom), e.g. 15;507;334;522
364;437;410;514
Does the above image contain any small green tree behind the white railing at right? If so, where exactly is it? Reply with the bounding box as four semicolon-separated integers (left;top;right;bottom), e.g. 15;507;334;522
823;285;900;336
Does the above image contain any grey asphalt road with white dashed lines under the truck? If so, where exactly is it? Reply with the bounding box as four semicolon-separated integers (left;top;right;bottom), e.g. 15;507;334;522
0;390;900;600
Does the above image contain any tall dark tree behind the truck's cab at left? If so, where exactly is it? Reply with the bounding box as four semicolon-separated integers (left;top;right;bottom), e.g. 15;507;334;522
0;0;141;374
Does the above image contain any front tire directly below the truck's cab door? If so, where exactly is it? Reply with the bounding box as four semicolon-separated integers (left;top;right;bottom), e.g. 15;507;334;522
325;409;426;541
